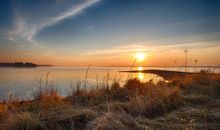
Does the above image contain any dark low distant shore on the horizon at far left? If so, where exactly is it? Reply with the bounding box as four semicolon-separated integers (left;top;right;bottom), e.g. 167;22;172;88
0;62;53;68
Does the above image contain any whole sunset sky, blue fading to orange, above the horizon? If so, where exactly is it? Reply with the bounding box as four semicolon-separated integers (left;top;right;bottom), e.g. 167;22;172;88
0;0;220;66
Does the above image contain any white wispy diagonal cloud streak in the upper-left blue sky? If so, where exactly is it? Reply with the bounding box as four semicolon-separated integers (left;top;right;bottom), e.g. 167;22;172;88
8;0;100;44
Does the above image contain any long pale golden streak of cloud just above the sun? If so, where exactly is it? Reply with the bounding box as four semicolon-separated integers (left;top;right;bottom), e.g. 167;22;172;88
84;39;219;55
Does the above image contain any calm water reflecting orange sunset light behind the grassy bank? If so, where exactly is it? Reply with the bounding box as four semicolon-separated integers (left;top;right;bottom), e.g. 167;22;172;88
0;67;220;100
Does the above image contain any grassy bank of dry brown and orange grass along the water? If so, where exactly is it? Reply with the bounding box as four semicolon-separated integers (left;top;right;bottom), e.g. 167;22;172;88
0;73;220;130
